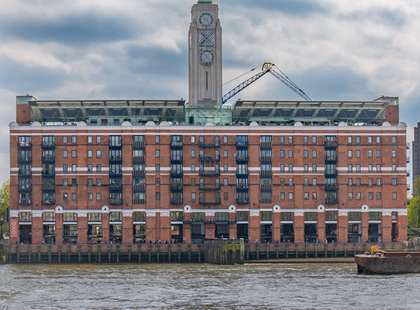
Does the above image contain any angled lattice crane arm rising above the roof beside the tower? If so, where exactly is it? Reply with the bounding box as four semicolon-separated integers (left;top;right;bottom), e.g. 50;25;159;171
222;62;312;104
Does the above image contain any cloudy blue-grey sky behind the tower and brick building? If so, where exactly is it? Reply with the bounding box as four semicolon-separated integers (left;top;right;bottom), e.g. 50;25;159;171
0;0;420;180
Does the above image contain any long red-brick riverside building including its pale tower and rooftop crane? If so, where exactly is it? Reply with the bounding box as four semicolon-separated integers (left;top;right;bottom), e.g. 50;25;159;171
9;0;407;245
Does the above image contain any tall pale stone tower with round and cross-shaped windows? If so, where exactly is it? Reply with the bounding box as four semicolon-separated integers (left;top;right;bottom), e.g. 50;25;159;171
188;0;222;109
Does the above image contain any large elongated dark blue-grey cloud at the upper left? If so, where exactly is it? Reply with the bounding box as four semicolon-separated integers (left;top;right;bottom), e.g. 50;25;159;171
0;12;140;45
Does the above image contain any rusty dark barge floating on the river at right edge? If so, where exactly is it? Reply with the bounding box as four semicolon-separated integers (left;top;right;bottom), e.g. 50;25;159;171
354;251;420;274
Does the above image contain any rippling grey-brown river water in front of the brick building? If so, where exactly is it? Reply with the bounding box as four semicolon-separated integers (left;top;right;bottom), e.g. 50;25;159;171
0;264;420;310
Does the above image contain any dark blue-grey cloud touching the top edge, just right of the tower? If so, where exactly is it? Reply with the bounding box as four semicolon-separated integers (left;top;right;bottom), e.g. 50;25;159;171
223;0;327;16
